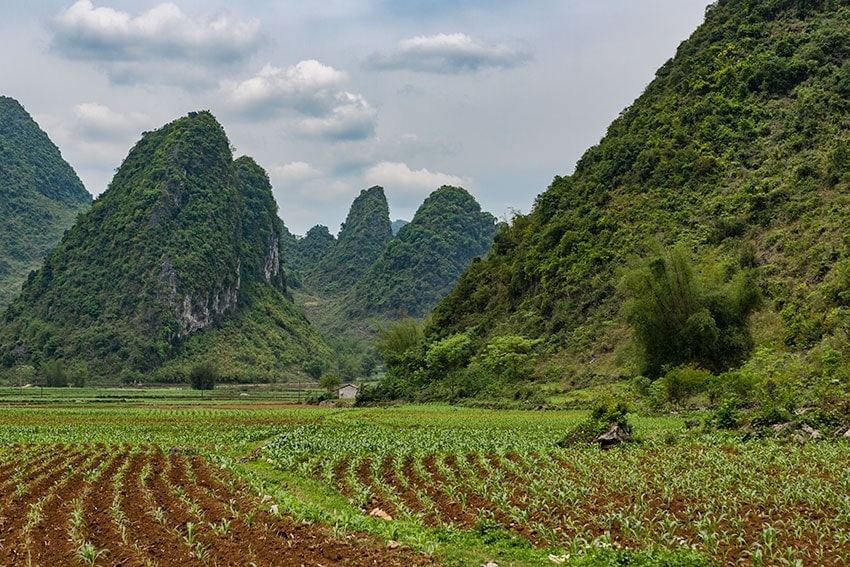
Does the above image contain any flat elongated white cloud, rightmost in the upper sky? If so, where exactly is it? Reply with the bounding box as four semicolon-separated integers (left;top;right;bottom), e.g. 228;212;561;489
366;33;531;74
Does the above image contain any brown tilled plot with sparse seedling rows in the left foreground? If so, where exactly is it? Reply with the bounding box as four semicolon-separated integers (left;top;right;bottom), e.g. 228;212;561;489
0;445;434;567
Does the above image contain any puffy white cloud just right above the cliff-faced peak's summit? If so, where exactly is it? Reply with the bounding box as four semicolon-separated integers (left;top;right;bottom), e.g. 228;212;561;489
222;59;347;117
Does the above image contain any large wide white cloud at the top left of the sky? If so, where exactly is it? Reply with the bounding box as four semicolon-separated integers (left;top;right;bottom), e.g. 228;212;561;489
51;0;263;86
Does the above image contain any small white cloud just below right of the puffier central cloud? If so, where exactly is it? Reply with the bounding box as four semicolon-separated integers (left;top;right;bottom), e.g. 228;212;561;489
300;92;377;141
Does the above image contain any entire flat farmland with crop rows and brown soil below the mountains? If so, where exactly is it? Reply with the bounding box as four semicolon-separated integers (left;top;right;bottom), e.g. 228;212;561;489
0;390;850;565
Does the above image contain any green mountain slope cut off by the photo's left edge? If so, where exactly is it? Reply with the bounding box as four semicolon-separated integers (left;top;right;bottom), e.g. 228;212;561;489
0;96;91;307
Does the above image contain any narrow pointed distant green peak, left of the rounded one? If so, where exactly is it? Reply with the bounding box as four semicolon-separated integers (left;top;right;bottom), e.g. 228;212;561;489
304;186;393;295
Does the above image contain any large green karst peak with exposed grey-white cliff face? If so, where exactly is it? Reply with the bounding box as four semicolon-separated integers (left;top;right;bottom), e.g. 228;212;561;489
0;112;328;381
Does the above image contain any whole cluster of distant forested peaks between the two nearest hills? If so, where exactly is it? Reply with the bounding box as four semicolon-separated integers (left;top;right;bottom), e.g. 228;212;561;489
281;186;495;381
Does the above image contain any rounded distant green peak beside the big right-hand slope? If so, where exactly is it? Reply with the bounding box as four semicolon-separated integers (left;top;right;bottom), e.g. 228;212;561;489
343;186;496;319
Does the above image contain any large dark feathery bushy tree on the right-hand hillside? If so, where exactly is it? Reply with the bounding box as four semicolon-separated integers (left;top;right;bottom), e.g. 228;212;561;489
620;247;759;378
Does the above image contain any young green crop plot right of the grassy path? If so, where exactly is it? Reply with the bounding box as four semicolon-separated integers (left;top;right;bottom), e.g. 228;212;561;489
263;423;850;565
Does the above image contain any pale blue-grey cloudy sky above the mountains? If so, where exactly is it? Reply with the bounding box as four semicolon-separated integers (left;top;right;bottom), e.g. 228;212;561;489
0;0;710;235
